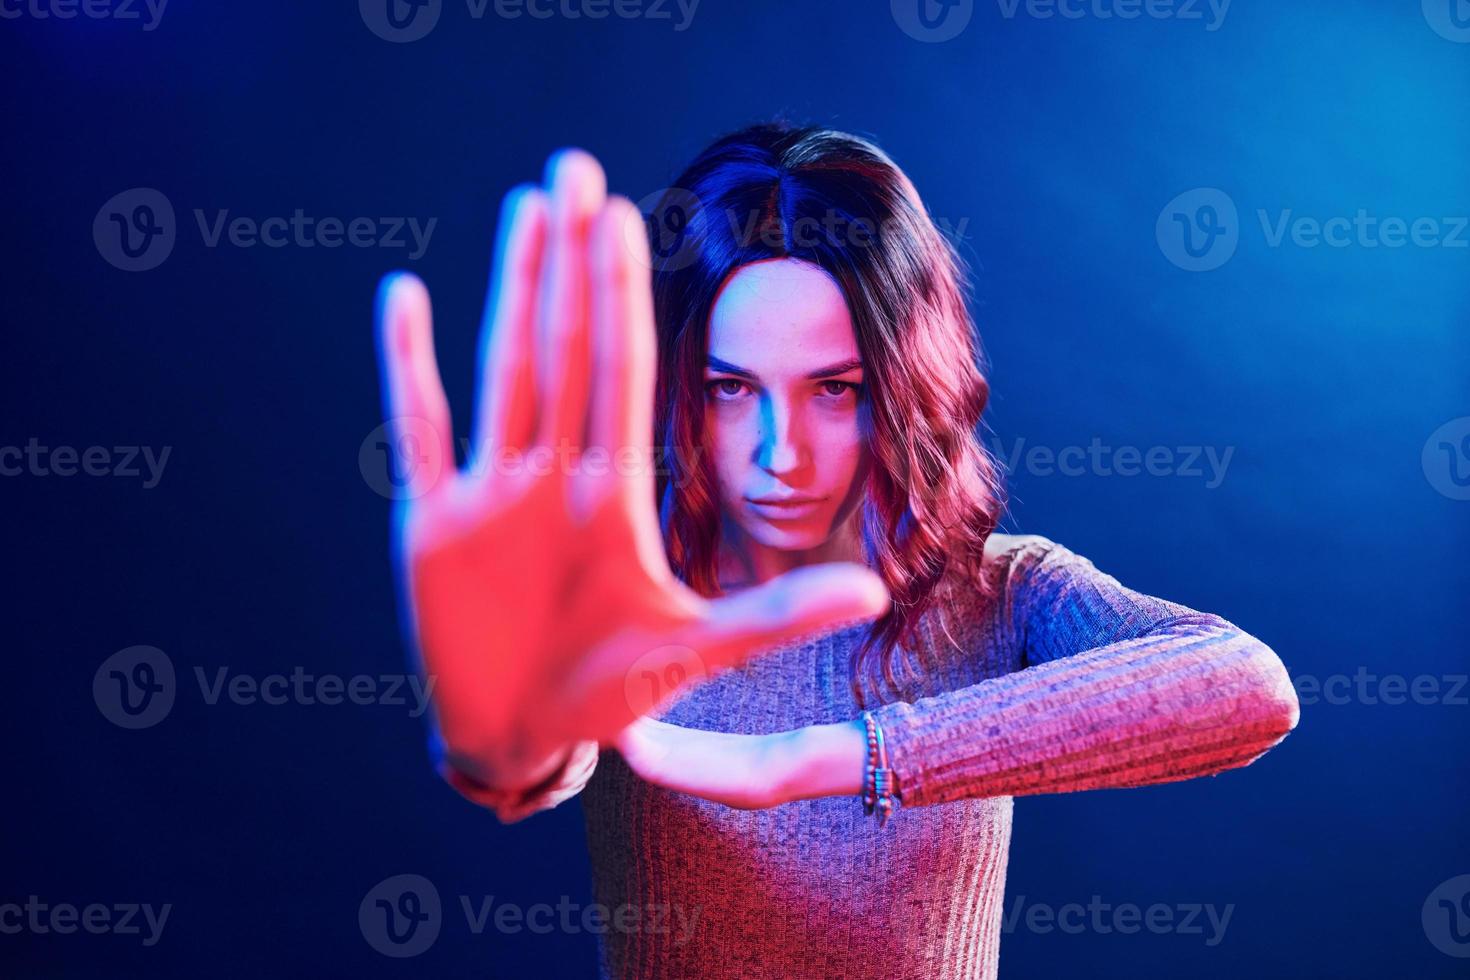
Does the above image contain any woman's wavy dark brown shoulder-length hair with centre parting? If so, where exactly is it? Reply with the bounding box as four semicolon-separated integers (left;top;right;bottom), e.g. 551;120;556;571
648;122;1005;705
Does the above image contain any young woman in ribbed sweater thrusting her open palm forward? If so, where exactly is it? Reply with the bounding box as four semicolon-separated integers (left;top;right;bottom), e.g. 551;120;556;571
378;125;1298;979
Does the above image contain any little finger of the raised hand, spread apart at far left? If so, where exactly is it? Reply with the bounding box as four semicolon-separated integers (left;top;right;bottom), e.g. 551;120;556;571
375;272;454;497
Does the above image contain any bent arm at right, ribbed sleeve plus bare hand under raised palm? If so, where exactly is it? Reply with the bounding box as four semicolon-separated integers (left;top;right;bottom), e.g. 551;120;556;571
622;535;1299;808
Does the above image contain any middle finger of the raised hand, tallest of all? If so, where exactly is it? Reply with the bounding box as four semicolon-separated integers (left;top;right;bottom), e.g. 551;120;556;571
537;150;607;447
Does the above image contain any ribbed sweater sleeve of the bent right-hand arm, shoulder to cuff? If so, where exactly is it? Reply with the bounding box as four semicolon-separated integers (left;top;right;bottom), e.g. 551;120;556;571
873;535;1298;807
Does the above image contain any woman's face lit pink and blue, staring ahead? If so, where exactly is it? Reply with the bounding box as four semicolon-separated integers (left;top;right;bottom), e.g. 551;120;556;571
704;259;869;551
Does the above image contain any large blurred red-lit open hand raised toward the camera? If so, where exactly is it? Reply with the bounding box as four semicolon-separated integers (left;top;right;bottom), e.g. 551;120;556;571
378;150;888;785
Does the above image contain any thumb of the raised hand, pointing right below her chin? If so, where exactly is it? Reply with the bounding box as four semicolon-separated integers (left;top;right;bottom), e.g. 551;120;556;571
694;561;891;669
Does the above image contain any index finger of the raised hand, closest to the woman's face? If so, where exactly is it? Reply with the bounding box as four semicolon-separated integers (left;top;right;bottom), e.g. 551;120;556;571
588;195;667;558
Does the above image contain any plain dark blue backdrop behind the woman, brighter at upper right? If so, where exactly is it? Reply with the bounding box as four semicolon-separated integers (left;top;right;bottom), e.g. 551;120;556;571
0;0;1470;977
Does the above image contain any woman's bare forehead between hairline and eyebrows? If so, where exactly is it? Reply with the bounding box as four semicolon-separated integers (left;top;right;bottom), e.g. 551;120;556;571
709;259;858;376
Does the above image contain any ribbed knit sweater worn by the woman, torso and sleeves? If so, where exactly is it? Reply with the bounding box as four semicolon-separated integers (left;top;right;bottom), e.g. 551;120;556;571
456;535;1298;980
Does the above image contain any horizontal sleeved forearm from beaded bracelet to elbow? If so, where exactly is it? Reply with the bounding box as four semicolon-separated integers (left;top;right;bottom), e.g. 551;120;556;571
875;620;1298;807
